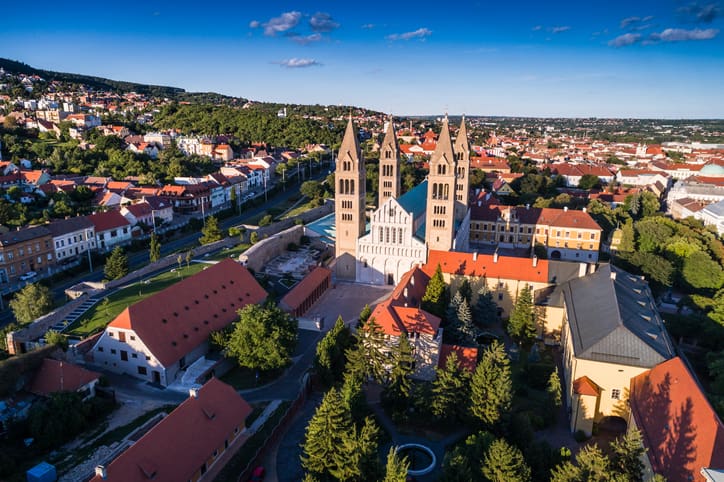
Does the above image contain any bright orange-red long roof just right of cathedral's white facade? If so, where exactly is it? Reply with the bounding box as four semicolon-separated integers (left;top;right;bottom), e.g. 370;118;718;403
422;250;548;283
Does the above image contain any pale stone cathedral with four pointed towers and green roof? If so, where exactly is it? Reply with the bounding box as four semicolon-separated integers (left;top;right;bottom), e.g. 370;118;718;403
335;116;470;285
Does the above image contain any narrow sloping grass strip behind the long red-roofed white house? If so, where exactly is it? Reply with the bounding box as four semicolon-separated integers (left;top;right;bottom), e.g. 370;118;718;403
65;263;208;338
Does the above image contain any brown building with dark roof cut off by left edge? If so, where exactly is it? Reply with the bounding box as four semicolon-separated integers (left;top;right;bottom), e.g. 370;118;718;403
0;226;55;285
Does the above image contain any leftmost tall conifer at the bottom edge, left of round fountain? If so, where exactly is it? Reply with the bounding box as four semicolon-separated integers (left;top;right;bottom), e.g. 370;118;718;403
302;388;356;480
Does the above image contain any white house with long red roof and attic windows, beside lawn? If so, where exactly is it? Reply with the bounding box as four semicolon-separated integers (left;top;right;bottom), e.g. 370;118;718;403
92;259;267;385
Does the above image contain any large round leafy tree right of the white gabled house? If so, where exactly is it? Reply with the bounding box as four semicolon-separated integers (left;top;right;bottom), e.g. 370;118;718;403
224;304;297;370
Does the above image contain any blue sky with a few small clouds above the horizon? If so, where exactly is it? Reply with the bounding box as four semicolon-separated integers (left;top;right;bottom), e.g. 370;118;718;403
0;0;724;118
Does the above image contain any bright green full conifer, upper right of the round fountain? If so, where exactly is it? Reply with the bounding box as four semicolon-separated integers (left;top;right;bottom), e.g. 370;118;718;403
470;341;513;427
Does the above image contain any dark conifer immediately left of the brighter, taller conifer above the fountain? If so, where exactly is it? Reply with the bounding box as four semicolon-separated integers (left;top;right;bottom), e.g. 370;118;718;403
430;352;470;421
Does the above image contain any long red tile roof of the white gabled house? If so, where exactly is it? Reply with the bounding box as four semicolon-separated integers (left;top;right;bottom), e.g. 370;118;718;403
108;259;267;366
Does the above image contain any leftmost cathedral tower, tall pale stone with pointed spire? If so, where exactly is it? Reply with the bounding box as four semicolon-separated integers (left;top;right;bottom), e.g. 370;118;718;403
334;116;366;280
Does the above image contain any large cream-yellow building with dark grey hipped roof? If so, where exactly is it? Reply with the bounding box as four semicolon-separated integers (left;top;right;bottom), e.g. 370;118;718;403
551;264;675;435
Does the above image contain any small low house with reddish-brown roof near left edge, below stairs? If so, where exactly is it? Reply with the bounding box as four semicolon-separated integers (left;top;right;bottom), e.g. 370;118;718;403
28;358;101;400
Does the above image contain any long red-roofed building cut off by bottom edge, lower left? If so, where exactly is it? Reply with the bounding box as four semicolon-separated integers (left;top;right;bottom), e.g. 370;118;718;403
91;378;252;482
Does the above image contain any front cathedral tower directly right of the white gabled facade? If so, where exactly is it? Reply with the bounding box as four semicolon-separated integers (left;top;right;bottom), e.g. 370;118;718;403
425;115;456;251
